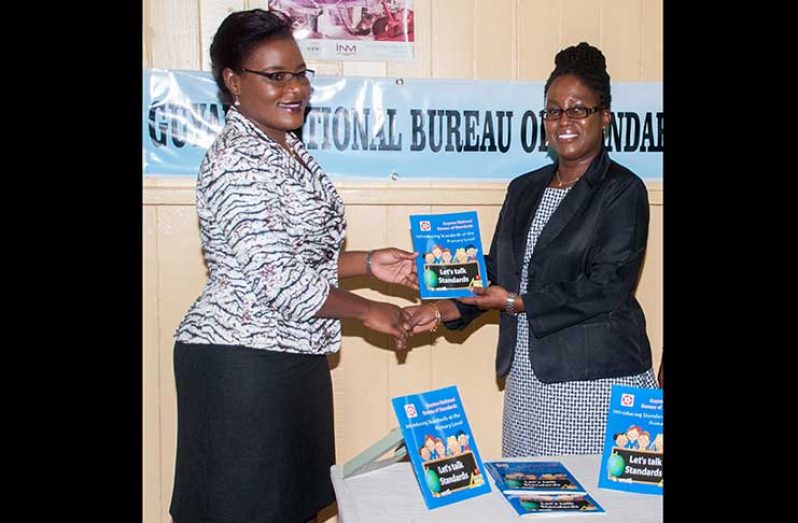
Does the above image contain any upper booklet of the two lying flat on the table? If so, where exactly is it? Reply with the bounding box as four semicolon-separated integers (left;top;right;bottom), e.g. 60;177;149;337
485;461;585;495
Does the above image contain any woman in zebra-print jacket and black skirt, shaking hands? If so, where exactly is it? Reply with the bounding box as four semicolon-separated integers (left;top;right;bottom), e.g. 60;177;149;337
170;9;416;523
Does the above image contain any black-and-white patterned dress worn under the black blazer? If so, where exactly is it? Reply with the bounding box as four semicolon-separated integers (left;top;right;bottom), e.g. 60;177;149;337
502;187;657;457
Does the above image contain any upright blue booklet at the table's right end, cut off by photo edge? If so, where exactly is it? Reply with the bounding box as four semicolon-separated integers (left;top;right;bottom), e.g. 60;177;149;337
599;385;664;495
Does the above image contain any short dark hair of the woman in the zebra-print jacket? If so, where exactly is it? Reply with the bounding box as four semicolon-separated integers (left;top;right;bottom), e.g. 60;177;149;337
211;9;293;102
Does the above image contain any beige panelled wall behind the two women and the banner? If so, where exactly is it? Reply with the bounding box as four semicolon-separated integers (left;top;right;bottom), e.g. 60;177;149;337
142;0;663;523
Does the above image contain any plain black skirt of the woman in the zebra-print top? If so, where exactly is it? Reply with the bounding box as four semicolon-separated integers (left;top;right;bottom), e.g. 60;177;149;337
169;342;335;523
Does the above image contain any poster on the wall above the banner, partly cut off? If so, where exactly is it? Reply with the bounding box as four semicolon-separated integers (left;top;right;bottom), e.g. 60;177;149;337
269;0;414;62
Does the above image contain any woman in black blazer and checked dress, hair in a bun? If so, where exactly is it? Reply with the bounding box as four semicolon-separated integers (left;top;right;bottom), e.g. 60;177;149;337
409;42;657;456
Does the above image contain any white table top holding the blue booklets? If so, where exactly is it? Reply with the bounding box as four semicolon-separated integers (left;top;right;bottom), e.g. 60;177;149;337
330;454;662;523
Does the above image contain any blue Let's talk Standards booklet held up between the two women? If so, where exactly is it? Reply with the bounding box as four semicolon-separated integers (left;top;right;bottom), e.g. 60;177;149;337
410;211;488;300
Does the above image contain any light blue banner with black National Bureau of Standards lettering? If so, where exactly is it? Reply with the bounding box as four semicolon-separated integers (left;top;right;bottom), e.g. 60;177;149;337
142;69;664;181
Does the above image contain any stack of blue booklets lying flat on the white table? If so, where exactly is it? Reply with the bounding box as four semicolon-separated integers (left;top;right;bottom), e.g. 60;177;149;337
485;461;605;517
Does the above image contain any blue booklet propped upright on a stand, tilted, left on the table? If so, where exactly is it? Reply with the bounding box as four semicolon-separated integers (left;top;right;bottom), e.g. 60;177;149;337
391;385;490;509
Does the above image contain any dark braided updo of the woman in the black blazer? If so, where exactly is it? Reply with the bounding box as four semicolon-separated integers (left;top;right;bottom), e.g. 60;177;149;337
543;42;612;109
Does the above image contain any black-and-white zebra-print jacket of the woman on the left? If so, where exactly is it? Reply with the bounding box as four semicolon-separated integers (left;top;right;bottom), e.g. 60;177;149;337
176;106;346;354
